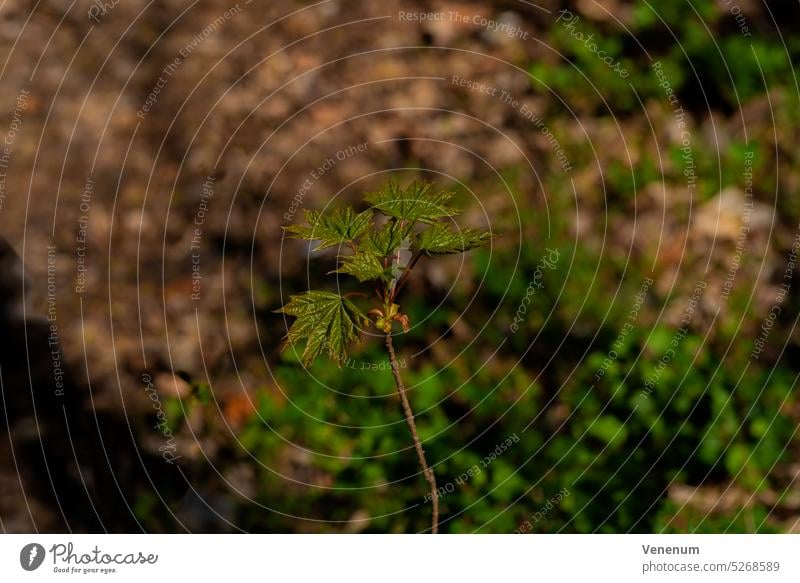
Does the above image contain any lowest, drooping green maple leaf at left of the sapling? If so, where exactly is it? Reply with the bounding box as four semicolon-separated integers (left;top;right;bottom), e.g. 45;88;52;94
277;290;369;366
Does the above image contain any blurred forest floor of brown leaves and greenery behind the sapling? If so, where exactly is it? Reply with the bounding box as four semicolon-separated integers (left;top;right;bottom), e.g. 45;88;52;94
0;0;800;533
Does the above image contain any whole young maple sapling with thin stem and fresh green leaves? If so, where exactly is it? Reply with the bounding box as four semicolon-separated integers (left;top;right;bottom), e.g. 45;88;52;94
278;182;492;534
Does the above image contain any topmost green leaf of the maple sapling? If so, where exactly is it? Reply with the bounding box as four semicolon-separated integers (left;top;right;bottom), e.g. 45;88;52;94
364;182;459;223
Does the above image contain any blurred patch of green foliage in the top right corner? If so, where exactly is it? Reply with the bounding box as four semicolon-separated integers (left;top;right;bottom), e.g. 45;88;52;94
529;0;800;114
